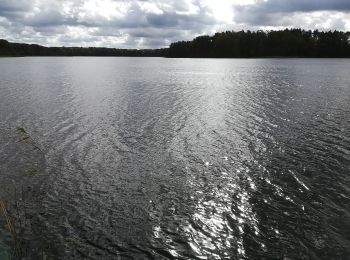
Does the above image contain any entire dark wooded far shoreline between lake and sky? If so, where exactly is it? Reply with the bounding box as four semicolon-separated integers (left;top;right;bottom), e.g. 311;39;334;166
0;29;350;58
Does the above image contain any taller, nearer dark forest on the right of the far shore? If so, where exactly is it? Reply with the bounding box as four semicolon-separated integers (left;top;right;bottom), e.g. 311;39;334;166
168;29;350;58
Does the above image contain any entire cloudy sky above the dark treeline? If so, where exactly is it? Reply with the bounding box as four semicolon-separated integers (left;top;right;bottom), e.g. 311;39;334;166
0;0;350;48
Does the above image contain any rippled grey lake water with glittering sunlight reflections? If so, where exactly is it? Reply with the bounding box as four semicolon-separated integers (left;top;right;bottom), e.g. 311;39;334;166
0;58;350;259
